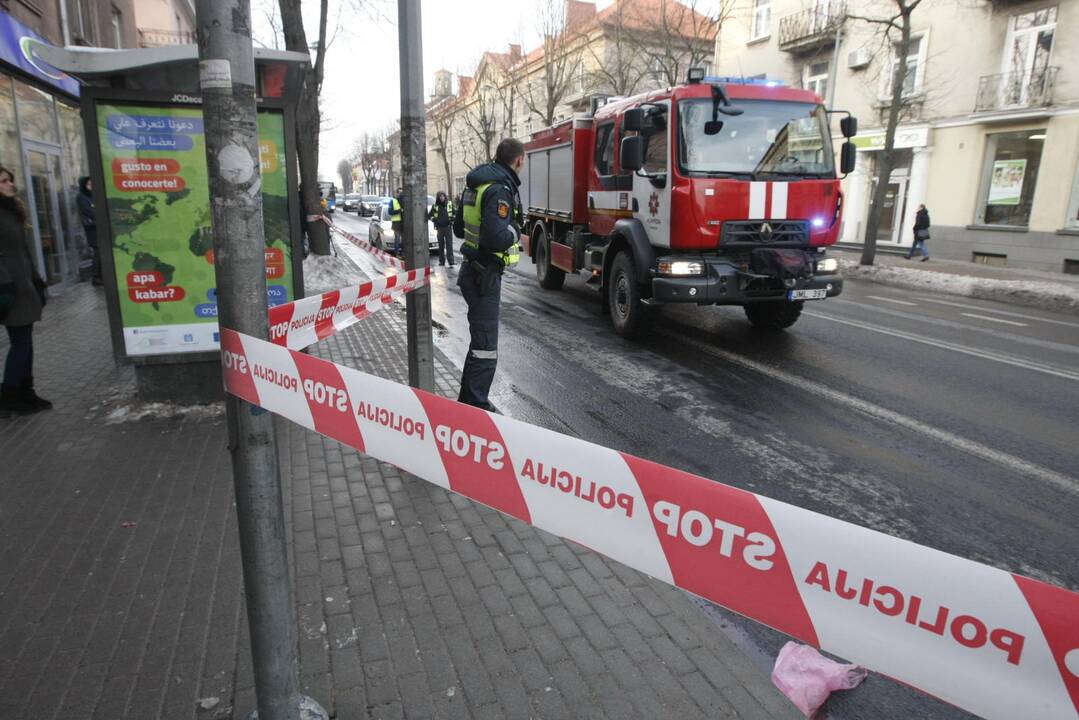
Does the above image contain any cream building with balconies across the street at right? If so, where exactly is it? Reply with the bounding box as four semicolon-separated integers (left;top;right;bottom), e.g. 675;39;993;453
715;0;1079;272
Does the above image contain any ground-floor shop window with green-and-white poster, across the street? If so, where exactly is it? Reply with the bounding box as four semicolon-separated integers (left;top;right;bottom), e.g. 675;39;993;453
978;128;1046;228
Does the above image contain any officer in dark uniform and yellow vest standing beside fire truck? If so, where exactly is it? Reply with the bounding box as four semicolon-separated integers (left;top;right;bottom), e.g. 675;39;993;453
453;138;524;410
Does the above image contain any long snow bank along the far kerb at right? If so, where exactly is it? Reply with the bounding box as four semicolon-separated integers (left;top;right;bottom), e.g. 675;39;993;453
839;258;1079;314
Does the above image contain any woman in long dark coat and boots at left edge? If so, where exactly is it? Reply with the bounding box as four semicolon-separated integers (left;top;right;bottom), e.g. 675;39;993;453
0;166;53;415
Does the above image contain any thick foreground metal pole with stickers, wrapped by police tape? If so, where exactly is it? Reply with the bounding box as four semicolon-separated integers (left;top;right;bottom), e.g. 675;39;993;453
196;0;326;720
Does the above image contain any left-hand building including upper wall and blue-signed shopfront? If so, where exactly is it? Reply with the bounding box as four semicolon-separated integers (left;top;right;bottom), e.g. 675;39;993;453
0;0;136;287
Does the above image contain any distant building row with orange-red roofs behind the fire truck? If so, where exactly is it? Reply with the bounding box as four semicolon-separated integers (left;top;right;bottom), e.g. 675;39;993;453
426;0;718;195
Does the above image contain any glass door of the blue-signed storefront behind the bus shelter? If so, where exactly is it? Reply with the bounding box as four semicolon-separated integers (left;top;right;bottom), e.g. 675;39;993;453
24;147;67;285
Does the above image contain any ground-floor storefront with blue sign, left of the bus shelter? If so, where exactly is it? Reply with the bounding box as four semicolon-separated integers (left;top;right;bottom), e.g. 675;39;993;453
0;11;90;288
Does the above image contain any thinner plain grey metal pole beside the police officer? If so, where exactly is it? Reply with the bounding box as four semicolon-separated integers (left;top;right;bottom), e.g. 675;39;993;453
397;0;435;392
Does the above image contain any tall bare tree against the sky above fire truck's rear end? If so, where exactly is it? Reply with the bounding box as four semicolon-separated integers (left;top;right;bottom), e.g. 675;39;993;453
521;0;581;125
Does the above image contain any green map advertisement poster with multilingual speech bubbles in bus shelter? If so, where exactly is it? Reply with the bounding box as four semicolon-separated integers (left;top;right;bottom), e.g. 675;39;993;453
97;104;295;355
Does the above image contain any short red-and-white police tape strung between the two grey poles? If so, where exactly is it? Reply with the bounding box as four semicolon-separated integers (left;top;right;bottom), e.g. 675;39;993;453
270;268;431;350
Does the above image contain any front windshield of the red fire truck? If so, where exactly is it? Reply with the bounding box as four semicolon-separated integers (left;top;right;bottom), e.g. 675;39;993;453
678;98;835;180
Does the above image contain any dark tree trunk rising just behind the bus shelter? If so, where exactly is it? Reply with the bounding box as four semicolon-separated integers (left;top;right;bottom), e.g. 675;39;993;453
279;0;330;255
